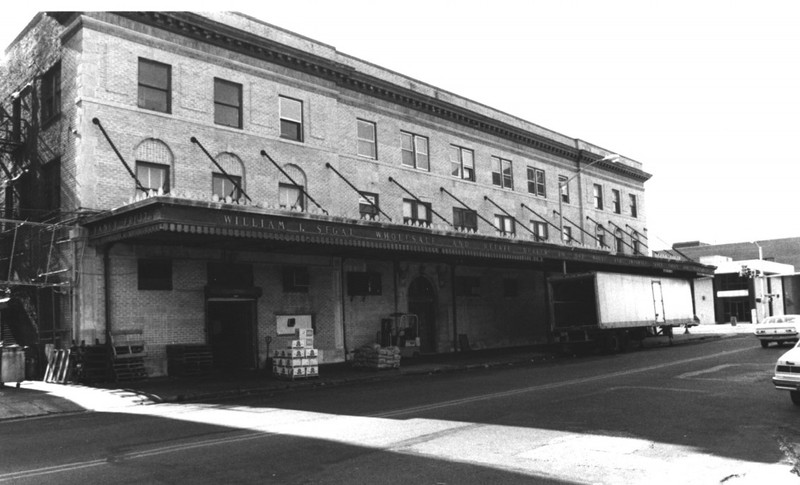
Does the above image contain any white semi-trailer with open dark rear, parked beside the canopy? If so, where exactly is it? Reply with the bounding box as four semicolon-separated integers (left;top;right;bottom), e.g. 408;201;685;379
548;272;695;352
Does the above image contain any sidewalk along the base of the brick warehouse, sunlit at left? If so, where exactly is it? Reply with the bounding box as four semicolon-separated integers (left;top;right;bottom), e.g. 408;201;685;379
0;324;755;421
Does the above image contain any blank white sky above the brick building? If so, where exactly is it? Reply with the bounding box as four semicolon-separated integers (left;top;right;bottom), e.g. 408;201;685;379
0;0;800;249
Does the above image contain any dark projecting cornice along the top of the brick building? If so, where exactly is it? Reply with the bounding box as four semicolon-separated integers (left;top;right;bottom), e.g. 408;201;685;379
48;12;650;182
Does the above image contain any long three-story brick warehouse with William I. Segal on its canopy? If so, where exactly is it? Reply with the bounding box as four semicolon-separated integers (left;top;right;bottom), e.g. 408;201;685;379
0;12;708;375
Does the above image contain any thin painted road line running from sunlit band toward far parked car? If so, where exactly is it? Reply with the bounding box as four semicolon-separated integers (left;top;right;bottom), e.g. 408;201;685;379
370;348;751;418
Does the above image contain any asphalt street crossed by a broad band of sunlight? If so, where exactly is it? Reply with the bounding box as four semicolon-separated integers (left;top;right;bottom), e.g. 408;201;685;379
0;336;800;484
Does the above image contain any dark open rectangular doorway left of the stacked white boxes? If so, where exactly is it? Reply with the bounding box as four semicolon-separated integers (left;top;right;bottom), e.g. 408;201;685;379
206;299;257;371
